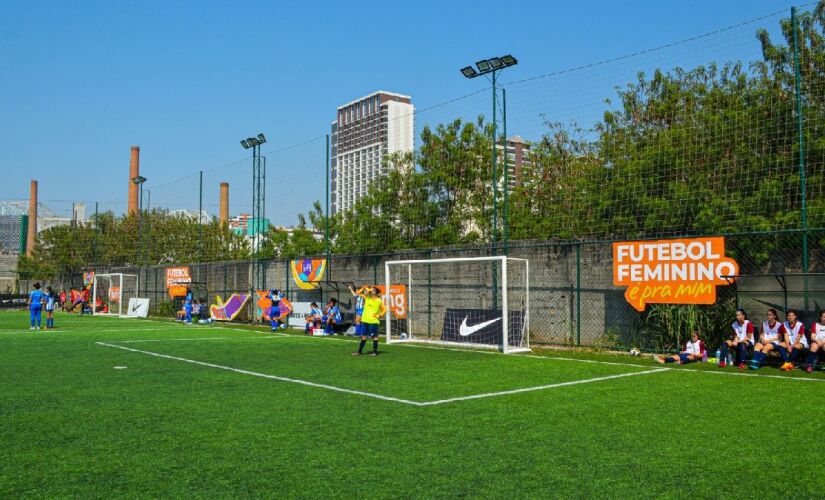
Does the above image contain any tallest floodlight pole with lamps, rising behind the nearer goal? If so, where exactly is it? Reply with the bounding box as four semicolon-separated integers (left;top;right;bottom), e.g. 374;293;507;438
461;54;518;308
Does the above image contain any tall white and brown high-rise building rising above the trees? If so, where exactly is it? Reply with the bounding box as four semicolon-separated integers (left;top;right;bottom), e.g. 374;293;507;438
330;90;415;214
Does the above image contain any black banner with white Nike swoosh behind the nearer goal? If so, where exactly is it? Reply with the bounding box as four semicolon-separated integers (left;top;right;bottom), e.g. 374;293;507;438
441;309;524;345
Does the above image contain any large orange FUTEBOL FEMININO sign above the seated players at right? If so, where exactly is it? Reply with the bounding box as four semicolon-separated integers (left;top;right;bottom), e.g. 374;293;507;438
613;236;739;311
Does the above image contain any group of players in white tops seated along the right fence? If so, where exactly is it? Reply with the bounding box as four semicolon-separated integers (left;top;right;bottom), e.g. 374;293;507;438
656;309;825;373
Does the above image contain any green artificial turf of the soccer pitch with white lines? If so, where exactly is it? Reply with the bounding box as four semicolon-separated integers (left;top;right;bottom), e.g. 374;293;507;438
0;312;825;498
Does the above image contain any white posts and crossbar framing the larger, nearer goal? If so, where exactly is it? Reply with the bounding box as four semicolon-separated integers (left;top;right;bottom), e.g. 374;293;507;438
384;255;530;354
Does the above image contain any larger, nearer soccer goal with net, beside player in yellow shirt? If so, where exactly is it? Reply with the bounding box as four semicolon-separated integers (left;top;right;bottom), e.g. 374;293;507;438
384;256;530;353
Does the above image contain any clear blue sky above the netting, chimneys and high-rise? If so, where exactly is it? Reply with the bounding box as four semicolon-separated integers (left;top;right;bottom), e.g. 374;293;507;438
0;0;791;223
